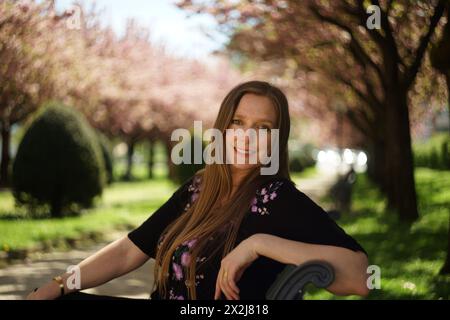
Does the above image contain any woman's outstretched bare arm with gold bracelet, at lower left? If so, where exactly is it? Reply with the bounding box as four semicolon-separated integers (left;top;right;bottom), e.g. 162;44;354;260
29;236;149;299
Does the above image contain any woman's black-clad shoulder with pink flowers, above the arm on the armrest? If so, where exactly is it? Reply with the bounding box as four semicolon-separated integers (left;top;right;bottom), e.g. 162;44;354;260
245;179;364;251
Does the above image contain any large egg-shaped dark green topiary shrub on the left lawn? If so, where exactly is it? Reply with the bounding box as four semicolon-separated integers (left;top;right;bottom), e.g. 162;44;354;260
13;103;105;217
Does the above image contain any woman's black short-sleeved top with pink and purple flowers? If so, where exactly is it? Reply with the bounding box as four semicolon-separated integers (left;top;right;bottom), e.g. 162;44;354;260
128;176;365;300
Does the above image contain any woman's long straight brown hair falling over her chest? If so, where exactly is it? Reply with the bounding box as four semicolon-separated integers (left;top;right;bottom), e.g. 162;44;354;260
155;81;290;299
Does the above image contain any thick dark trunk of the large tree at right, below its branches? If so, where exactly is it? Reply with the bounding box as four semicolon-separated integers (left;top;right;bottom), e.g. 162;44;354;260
385;88;419;222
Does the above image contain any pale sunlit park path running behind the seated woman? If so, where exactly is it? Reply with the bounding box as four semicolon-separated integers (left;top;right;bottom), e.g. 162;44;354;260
0;173;336;300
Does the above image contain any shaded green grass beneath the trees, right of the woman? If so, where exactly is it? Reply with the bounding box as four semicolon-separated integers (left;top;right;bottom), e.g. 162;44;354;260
305;168;450;299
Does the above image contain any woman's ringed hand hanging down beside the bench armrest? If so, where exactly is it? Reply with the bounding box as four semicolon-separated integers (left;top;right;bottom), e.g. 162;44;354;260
214;236;258;300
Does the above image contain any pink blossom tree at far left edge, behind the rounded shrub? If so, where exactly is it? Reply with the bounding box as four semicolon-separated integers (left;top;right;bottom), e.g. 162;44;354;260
0;0;77;185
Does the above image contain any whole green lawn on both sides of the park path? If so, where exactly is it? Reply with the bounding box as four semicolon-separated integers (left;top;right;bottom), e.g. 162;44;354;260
0;168;450;299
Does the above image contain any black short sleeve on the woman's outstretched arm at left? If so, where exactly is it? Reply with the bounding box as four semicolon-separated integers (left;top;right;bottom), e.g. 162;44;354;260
128;178;193;258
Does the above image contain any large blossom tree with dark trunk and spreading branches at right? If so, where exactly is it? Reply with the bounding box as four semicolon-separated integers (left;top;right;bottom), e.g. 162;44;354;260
179;0;445;221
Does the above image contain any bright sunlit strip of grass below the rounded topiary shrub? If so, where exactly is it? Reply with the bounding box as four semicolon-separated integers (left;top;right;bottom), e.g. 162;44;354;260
0;179;175;251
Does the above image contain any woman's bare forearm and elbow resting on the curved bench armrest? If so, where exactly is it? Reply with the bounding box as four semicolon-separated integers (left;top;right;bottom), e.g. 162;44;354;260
252;234;368;296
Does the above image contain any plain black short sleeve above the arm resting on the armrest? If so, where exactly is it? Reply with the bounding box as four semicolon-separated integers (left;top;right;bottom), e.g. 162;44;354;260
260;180;367;255
